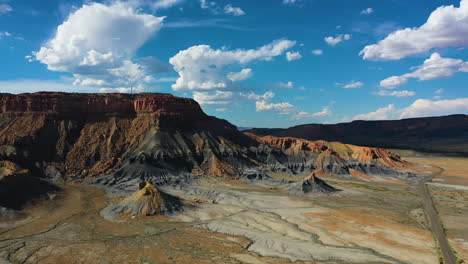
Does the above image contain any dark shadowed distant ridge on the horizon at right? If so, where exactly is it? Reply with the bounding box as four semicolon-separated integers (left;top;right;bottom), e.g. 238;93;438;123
244;114;468;155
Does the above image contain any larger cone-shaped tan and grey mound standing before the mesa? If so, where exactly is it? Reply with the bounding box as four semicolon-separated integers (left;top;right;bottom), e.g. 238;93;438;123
101;181;183;220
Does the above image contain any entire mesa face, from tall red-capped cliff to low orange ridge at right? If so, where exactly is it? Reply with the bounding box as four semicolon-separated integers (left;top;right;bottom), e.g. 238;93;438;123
0;92;414;203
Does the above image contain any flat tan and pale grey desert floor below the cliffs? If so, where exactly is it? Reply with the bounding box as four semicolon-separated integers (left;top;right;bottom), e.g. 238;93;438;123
0;154;468;264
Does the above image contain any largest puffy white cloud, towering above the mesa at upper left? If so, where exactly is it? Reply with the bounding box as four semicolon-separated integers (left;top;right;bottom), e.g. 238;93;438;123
34;2;163;91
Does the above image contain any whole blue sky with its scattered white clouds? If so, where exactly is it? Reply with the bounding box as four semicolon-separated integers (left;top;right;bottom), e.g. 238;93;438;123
0;0;468;127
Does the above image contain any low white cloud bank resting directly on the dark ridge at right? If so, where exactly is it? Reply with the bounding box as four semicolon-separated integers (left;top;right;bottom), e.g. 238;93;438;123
353;98;468;120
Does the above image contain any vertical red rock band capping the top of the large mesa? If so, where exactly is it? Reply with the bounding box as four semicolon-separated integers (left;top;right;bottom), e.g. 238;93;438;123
0;92;205;118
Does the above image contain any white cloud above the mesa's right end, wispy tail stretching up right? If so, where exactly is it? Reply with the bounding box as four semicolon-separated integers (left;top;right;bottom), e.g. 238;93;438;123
169;39;296;91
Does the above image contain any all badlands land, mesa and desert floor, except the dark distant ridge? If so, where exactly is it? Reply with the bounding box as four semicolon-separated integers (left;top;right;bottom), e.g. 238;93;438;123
0;93;468;264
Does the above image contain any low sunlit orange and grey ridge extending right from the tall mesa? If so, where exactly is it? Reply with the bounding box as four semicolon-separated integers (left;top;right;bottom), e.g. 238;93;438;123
245;133;414;178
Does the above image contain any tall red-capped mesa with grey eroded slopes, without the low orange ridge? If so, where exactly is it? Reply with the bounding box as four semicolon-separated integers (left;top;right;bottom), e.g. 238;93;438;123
0;93;252;183
